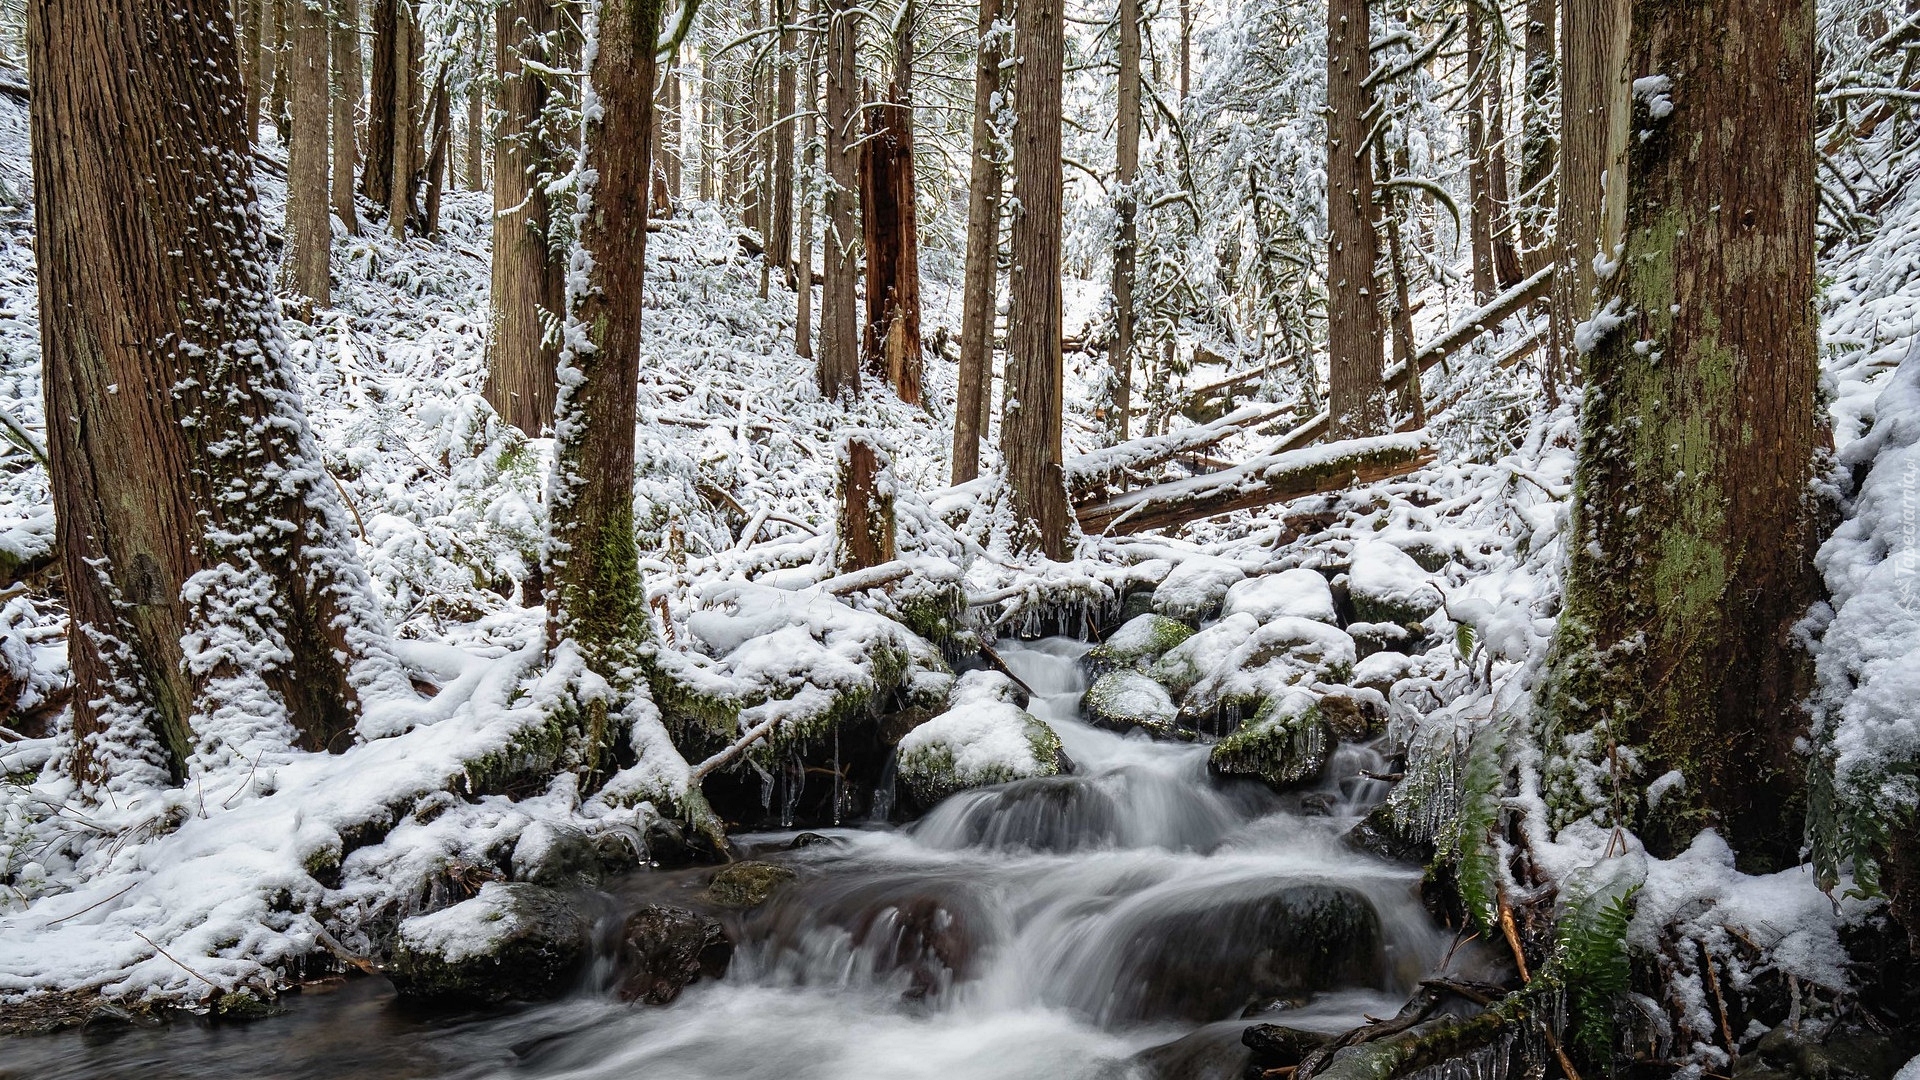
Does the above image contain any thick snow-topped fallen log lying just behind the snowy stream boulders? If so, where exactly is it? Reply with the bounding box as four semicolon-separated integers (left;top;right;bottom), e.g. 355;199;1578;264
1077;430;1434;536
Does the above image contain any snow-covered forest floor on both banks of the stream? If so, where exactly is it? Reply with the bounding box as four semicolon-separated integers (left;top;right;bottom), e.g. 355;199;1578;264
0;82;1920;1065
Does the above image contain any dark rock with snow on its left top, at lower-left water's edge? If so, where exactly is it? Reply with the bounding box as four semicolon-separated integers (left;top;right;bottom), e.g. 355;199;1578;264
388;882;591;1003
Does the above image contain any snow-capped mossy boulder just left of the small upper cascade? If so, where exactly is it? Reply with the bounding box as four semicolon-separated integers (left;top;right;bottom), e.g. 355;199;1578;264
897;671;1068;807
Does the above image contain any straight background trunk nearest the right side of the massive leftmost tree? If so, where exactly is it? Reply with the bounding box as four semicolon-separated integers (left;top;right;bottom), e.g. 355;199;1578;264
280;0;334;307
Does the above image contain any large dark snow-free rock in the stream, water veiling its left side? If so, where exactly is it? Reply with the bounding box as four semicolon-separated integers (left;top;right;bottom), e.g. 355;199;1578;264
1089;884;1386;1022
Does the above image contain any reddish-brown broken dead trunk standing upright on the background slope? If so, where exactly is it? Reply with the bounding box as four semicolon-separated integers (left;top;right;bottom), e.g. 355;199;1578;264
860;11;924;405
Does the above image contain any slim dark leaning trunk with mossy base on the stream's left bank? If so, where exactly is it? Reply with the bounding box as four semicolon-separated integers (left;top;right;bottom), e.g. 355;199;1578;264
547;0;660;714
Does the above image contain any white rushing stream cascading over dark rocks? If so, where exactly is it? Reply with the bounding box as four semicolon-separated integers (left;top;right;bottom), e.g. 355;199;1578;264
0;640;1450;1080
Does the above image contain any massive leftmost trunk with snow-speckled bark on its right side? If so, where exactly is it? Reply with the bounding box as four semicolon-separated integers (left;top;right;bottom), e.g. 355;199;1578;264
27;0;407;780
